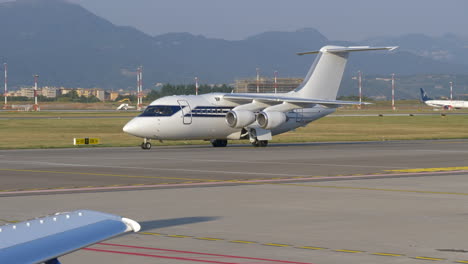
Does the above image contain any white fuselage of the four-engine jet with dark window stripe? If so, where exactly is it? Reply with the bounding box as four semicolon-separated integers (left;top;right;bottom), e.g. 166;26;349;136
123;93;335;140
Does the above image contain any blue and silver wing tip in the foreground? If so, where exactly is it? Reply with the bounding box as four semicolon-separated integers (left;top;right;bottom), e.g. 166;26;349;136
0;210;140;263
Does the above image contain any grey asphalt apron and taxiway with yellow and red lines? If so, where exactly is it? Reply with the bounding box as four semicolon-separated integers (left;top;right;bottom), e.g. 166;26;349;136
0;140;468;264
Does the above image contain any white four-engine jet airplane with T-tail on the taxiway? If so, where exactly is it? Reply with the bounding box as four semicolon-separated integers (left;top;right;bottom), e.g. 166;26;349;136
123;46;397;149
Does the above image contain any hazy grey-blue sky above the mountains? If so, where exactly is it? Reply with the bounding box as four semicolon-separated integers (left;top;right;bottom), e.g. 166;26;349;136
9;0;468;40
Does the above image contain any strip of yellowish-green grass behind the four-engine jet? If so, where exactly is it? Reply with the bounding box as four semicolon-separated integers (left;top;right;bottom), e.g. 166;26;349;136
0;113;468;149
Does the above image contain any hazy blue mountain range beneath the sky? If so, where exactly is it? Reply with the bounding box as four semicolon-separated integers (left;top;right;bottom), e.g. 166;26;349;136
0;0;468;95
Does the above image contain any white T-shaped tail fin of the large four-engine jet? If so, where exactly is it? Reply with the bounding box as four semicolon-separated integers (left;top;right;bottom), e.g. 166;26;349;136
291;46;398;100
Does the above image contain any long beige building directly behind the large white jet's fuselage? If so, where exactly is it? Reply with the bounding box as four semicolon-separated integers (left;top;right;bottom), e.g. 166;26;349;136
235;78;303;93
